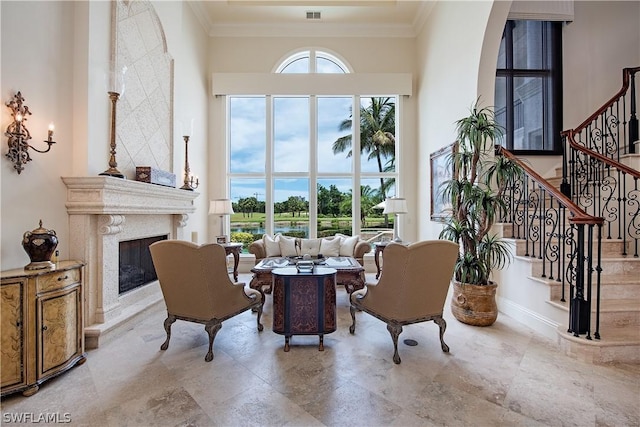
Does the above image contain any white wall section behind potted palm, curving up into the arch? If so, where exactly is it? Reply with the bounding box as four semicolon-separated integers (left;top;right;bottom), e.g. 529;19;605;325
415;1;504;240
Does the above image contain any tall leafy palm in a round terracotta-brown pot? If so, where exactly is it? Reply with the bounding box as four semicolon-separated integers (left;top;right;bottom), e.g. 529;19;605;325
439;101;523;326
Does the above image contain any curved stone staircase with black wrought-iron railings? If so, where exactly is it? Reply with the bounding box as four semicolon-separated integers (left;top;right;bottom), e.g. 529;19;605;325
497;67;640;364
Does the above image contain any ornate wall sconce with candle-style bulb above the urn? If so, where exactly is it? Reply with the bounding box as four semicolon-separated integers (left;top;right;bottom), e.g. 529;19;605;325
4;91;56;174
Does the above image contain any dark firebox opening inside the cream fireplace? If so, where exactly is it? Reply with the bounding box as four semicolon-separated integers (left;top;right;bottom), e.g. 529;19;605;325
118;235;168;294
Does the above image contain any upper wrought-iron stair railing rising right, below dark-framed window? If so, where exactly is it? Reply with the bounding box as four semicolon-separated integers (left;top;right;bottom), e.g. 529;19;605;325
560;67;640;257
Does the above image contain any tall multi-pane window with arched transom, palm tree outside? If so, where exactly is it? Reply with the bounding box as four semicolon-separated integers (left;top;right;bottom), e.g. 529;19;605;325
227;51;397;242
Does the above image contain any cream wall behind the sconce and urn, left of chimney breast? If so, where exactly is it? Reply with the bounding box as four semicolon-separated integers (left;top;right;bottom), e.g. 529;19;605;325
0;1;74;270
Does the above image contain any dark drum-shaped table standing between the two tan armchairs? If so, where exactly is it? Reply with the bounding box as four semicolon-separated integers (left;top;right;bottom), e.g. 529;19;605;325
271;267;337;351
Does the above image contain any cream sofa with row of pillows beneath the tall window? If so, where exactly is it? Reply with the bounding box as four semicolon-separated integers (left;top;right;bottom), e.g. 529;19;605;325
249;233;371;265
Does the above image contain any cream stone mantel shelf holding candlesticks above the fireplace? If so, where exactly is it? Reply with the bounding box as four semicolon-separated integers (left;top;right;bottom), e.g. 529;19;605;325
62;176;200;215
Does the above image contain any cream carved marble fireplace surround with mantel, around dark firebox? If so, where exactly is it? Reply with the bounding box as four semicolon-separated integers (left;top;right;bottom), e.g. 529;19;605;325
62;176;199;348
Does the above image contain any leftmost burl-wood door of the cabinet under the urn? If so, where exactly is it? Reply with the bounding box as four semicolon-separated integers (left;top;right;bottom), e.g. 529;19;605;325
0;280;27;391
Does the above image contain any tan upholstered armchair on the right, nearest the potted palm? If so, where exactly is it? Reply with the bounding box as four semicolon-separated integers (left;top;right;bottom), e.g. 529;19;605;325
349;240;458;363
